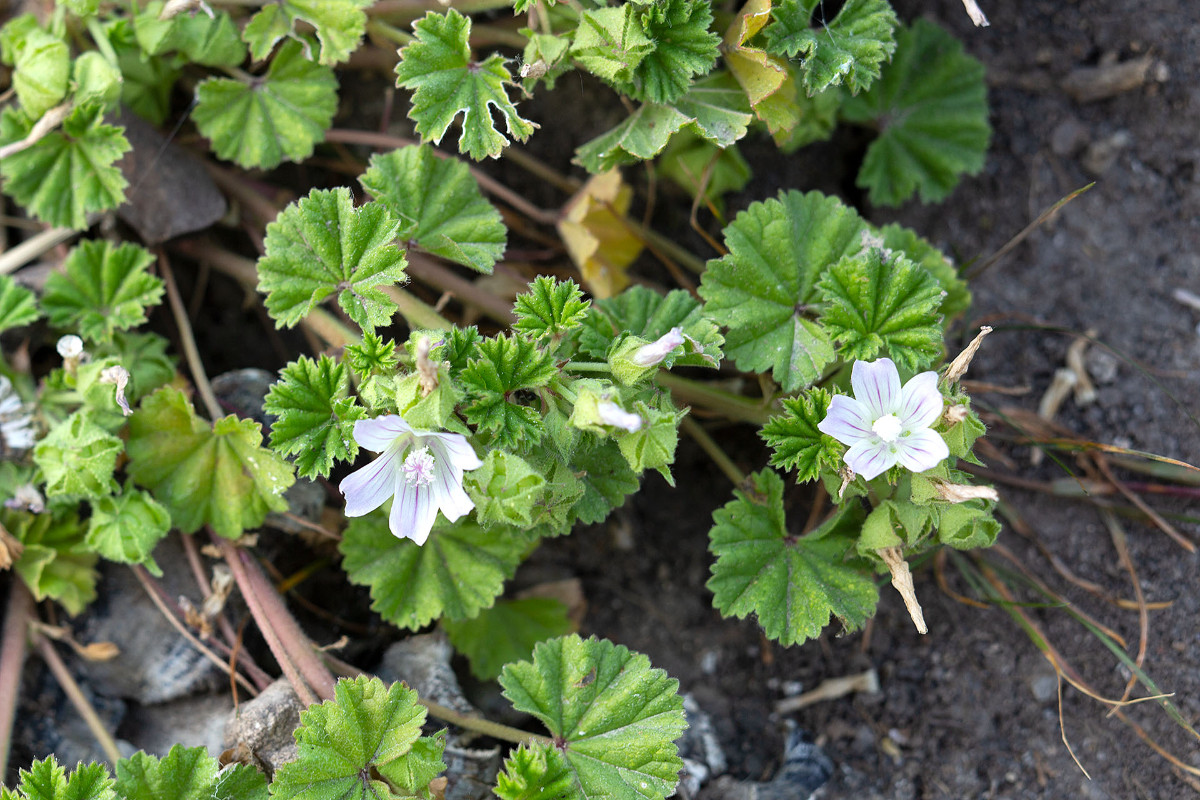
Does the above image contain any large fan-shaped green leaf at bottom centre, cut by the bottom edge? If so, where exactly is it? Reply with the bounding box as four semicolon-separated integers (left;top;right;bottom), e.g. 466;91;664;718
500;636;688;800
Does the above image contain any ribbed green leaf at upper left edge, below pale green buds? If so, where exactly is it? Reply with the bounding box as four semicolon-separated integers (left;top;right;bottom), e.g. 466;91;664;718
0;103;130;230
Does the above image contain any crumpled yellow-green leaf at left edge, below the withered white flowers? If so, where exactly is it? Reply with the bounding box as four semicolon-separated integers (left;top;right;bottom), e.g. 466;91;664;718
2;511;98;615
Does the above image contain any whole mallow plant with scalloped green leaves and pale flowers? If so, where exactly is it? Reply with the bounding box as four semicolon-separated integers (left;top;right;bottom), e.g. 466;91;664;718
0;0;998;800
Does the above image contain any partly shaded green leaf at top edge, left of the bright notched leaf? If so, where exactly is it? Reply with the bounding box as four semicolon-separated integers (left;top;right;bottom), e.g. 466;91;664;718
133;0;246;67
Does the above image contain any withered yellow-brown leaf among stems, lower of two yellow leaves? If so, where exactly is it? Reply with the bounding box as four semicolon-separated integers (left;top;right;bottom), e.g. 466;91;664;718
558;169;642;300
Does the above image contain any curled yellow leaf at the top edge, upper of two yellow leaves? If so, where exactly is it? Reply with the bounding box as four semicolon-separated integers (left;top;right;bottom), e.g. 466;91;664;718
725;0;802;142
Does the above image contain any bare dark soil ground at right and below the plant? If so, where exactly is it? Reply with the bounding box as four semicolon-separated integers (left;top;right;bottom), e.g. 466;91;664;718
9;0;1200;800
